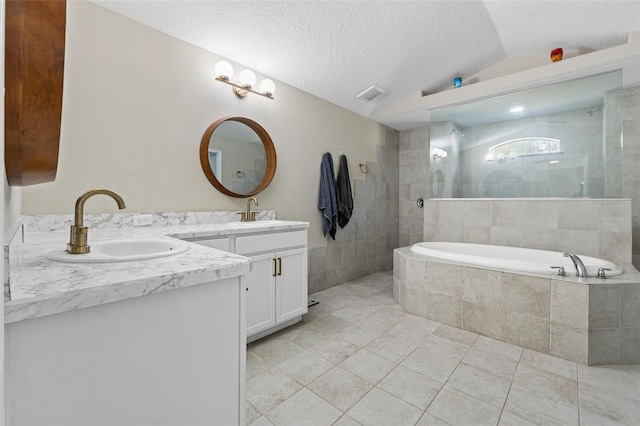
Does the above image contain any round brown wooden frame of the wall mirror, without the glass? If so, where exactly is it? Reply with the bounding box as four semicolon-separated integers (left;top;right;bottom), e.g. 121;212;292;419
200;117;277;198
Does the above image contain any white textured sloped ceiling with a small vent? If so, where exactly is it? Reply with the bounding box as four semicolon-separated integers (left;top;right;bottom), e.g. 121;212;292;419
93;0;640;130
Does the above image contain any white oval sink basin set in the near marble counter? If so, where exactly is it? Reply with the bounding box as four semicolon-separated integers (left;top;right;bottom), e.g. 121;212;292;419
46;238;191;263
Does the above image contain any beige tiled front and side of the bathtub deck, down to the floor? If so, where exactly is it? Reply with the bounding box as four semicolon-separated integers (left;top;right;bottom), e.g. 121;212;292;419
393;247;640;365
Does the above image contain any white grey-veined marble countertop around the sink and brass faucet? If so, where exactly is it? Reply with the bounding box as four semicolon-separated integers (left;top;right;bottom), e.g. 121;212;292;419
5;220;309;324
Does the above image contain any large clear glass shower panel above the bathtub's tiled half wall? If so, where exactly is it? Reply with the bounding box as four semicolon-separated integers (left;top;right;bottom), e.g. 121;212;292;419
430;71;622;198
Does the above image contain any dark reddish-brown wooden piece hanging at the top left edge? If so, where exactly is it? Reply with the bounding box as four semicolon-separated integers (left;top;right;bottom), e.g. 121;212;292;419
4;0;67;186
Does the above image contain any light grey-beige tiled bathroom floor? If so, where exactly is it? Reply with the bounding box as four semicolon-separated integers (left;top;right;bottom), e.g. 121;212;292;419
247;273;640;426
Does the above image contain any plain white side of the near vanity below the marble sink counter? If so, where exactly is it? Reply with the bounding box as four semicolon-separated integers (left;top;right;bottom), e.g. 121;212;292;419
5;276;248;426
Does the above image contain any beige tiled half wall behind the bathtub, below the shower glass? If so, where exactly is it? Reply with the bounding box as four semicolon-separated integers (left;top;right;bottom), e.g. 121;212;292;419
424;198;633;263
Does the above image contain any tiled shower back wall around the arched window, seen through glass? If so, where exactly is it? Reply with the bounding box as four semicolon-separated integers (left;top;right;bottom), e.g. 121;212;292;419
456;107;604;198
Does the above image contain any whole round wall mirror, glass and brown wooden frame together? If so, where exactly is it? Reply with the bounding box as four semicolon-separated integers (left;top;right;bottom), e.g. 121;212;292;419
200;117;276;198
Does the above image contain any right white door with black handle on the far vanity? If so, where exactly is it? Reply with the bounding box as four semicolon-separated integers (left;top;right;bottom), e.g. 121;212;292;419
272;248;308;324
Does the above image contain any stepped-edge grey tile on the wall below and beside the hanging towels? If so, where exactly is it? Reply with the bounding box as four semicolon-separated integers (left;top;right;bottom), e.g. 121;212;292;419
309;130;398;293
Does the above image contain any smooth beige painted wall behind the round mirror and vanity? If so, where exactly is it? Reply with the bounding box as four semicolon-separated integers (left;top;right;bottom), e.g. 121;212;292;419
20;1;386;247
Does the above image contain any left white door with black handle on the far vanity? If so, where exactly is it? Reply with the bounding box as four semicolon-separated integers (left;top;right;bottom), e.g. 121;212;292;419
242;253;276;336
